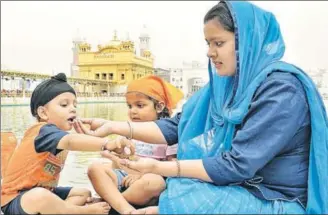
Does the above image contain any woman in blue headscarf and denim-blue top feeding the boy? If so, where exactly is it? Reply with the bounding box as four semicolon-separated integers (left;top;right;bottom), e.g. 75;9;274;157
77;1;328;214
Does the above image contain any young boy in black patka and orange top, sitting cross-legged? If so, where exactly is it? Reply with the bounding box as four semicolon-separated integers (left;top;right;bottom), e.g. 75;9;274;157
1;73;132;215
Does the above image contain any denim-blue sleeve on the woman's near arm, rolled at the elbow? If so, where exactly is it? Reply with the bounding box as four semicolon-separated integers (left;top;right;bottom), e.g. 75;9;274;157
203;73;309;185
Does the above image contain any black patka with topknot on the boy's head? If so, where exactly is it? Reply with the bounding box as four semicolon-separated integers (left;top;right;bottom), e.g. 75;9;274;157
30;73;76;117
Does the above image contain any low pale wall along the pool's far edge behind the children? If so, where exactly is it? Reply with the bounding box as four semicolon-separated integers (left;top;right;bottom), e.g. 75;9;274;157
1;97;125;106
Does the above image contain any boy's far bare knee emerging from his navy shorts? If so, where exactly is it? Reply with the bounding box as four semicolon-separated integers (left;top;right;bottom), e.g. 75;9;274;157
65;187;92;206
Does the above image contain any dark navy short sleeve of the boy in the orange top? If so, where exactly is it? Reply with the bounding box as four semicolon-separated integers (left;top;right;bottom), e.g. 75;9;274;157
34;124;68;155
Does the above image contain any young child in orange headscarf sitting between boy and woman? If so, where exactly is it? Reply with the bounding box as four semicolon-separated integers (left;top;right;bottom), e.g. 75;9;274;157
88;76;183;214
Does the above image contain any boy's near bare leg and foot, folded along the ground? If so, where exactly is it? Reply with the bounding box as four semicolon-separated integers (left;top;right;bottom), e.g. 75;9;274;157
21;187;110;214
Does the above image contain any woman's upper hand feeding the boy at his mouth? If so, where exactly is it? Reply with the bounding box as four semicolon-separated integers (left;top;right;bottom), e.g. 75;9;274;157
73;118;112;137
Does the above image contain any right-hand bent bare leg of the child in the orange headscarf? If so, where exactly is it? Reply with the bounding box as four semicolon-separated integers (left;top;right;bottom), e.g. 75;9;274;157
123;173;166;205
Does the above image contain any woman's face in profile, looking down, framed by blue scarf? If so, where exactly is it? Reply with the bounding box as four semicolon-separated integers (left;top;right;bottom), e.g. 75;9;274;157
204;18;236;76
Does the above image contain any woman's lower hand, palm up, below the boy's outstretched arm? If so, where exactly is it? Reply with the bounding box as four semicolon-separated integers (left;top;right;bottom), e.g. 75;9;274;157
101;151;160;174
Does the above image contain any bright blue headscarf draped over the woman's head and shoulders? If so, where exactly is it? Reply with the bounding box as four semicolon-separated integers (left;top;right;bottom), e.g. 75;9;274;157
178;1;328;214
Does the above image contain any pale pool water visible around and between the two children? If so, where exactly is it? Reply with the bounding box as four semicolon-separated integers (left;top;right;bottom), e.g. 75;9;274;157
1;103;127;192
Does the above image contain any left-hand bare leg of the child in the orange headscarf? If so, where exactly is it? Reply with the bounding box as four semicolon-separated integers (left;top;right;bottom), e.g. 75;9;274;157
88;163;135;214
